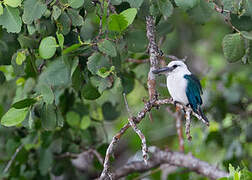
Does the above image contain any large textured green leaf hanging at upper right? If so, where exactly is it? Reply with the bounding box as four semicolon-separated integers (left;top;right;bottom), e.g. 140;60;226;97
222;33;245;62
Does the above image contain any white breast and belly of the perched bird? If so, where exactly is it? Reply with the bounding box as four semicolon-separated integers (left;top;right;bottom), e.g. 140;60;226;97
167;73;189;105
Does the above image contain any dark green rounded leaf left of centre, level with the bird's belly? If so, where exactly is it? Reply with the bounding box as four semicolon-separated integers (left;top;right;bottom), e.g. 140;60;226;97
81;83;101;100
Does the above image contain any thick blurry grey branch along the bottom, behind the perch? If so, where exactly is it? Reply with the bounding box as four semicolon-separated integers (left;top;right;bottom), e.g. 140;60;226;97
112;146;228;179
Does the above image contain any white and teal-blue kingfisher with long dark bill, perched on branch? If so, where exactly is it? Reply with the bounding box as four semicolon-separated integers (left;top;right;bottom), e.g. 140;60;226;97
152;60;209;122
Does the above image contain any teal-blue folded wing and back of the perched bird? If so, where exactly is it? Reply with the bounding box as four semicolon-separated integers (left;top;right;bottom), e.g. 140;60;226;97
184;74;202;112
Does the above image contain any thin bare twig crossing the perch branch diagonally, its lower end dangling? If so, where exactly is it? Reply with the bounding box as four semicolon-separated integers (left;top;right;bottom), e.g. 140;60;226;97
123;93;148;164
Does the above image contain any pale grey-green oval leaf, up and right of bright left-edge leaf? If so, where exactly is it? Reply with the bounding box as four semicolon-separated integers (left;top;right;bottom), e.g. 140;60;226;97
37;82;54;104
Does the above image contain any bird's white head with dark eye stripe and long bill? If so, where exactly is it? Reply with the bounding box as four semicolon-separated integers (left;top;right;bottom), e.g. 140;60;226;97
152;61;188;76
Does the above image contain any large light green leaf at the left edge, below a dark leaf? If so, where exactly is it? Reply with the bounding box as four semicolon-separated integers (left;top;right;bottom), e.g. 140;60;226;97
1;108;28;127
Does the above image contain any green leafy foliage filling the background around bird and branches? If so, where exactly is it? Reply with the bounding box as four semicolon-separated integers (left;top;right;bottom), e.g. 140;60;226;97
0;0;252;179
